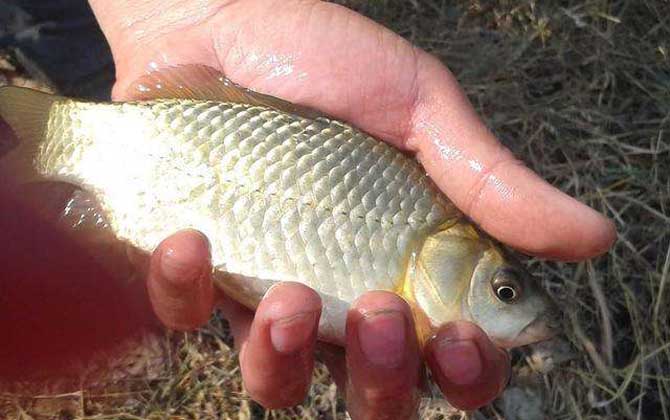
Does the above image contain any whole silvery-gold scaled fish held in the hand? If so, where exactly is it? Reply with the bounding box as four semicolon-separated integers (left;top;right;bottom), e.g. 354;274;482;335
0;65;559;348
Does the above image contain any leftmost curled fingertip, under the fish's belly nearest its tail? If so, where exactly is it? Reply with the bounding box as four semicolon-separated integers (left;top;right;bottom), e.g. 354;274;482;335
147;230;214;330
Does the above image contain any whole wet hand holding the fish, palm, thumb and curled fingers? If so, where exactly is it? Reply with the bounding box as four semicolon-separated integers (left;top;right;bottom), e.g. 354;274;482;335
0;0;615;418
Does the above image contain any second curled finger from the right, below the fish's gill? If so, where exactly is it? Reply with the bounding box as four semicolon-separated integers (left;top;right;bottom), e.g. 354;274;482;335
346;292;421;419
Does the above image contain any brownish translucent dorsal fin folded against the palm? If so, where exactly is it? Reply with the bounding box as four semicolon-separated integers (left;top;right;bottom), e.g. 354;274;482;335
129;64;324;119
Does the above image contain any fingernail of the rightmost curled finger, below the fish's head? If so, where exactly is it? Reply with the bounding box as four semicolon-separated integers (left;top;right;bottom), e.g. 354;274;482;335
434;338;483;385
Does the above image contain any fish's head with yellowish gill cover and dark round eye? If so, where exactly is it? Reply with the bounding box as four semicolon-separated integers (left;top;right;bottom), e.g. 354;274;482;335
408;226;560;348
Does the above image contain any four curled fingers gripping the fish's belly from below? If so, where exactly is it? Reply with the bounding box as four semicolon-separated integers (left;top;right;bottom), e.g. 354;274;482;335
148;226;509;418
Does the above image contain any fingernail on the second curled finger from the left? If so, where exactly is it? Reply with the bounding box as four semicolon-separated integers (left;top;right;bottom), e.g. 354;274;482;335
270;312;319;354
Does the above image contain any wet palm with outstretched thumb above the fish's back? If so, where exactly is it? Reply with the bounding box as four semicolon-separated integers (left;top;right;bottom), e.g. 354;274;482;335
96;0;614;260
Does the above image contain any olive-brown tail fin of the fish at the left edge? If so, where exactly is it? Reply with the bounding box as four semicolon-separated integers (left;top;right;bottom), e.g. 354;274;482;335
0;86;59;182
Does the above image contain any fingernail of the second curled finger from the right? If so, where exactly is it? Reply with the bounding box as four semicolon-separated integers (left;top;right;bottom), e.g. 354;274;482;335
357;311;407;368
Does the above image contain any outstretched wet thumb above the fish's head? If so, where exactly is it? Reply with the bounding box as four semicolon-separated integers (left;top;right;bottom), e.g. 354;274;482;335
407;54;616;260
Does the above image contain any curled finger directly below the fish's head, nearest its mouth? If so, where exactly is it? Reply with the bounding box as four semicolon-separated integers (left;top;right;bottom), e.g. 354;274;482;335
424;321;510;410
